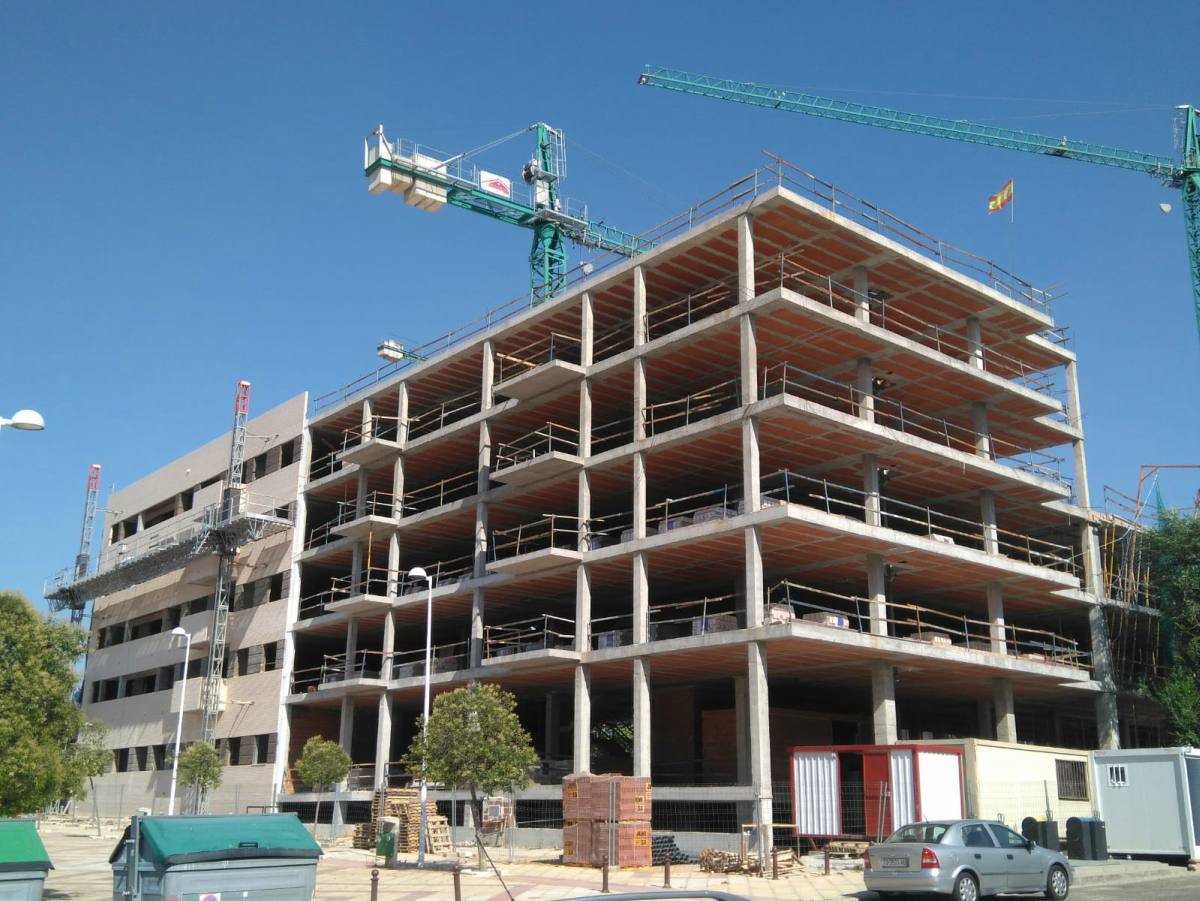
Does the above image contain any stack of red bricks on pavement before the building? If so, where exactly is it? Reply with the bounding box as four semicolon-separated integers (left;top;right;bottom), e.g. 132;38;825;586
563;773;652;867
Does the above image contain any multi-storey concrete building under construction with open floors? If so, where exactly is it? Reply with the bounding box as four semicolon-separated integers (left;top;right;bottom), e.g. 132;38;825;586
46;162;1152;828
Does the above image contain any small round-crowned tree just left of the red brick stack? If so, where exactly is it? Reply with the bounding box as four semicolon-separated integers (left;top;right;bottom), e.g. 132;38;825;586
403;681;538;860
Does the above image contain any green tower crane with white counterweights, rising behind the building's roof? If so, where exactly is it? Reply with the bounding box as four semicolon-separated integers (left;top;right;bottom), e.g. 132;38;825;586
362;122;643;302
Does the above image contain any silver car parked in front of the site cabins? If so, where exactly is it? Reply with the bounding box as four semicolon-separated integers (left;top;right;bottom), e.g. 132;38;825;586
863;819;1072;901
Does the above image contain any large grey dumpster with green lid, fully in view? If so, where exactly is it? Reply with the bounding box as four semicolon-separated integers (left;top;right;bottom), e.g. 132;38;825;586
108;813;322;901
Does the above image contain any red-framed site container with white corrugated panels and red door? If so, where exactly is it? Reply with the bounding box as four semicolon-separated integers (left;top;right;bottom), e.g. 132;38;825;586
791;744;964;839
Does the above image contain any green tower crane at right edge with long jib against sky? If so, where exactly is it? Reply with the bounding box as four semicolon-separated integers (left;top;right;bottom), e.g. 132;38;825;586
637;66;1200;338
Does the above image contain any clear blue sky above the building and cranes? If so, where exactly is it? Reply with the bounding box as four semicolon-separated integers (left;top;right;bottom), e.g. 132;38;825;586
0;0;1200;614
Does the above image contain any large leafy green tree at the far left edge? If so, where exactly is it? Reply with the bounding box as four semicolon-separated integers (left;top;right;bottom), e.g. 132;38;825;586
0;591;88;817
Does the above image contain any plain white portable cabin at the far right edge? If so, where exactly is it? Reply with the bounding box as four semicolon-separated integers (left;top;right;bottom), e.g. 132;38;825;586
1092;747;1200;860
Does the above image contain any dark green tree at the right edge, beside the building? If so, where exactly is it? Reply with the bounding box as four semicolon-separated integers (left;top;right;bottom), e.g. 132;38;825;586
1142;511;1200;747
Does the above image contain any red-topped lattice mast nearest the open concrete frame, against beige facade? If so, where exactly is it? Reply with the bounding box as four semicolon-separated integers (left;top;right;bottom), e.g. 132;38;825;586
196;380;250;813
